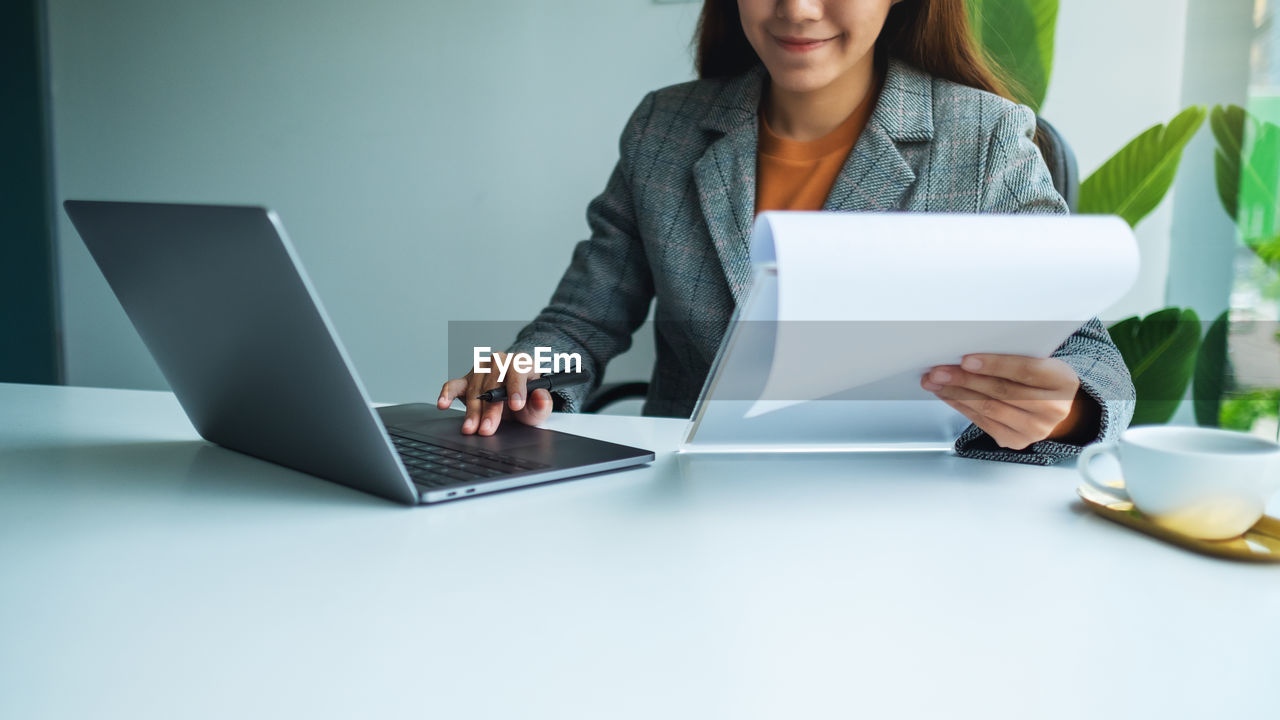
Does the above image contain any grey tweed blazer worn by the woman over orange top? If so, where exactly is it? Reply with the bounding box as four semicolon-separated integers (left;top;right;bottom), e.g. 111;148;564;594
512;60;1134;465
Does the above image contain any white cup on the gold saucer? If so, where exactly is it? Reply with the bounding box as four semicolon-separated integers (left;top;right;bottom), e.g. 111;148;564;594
1078;425;1280;539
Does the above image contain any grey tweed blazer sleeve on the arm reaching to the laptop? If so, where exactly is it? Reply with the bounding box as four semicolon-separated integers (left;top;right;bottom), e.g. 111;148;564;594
509;92;654;413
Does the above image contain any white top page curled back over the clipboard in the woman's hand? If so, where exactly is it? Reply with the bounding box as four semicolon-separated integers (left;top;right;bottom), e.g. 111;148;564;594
736;213;1138;418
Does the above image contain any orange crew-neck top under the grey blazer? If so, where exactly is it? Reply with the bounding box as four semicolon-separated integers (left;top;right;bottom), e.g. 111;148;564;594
755;85;879;213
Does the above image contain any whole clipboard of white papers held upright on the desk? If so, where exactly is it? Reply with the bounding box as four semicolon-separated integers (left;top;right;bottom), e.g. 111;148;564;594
686;213;1138;450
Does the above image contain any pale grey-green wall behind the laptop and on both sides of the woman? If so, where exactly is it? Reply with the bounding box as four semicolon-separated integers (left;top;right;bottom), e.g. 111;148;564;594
49;0;1239;400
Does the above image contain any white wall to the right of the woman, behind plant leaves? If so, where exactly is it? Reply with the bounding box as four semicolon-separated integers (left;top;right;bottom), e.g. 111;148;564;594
1043;0;1254;320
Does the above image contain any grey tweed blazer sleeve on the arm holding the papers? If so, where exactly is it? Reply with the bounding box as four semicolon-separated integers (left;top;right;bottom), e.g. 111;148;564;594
955;105;1137;465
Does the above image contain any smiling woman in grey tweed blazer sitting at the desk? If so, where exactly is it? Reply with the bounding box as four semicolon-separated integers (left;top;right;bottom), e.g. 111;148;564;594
439;0;1134;464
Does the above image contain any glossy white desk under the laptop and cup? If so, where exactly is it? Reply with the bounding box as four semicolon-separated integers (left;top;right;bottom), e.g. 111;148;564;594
0;384;1280;720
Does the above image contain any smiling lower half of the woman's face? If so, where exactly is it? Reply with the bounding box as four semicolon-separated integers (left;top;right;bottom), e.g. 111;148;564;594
737;0;897;92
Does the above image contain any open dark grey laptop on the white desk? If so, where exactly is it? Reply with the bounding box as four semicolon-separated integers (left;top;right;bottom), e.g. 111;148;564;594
63;200;654;505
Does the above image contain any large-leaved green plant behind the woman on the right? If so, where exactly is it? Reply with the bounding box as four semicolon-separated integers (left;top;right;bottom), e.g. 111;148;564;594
968;0;1280;429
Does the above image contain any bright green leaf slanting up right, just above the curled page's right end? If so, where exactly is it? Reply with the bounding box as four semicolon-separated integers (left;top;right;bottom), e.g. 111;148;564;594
1080;105;1206;227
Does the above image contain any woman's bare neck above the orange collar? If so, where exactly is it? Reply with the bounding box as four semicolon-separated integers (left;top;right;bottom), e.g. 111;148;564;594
764;53;876;142
